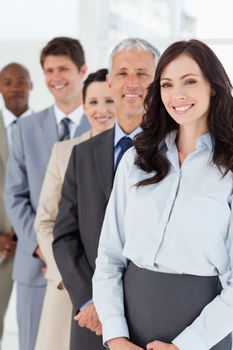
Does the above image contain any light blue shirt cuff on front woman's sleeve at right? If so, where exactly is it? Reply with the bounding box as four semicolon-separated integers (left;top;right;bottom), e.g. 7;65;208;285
172;327;209;350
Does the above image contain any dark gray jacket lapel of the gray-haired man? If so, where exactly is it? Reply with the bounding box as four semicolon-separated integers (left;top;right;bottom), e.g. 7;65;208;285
94;128;114;200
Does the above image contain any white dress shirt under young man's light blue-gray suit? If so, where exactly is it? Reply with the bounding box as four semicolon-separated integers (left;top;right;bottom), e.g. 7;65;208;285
54;105;84;139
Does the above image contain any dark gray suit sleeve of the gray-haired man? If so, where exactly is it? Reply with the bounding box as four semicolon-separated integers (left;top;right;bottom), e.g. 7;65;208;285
53;149;94;311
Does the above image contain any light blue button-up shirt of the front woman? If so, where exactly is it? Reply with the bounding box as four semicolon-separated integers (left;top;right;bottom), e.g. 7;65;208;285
93;132;233;350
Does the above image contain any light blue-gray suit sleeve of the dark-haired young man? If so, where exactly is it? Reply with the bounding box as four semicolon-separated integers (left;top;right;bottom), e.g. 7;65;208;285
4;123;37;254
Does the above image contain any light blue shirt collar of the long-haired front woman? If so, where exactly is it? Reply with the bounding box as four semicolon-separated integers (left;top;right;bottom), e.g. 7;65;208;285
159;130;214;152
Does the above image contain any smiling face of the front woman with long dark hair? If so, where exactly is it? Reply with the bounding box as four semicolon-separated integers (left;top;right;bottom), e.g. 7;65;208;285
160;54;212;128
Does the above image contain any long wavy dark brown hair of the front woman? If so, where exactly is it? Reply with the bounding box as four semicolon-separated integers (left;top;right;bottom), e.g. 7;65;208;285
135;39;233;186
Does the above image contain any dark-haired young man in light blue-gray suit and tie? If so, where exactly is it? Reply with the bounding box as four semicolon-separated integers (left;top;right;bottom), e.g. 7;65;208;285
5;37;89;350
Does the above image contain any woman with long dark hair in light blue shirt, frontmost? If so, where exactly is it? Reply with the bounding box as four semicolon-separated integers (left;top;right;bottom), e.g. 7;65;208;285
94;40;233;350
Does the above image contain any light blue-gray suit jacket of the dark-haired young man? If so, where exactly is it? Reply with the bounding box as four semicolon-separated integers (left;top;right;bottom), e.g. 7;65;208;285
4;106;90;286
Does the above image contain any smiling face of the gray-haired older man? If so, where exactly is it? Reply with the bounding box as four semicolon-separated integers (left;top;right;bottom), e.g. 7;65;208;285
109;49;156;118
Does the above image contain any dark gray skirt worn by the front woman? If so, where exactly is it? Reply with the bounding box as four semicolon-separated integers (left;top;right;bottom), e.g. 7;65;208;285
123;262;232;350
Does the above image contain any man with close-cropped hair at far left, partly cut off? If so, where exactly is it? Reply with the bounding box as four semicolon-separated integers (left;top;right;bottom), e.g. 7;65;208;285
0;63;32;347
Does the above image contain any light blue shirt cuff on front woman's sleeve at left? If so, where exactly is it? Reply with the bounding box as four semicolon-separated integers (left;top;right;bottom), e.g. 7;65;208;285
102;316;129;346
